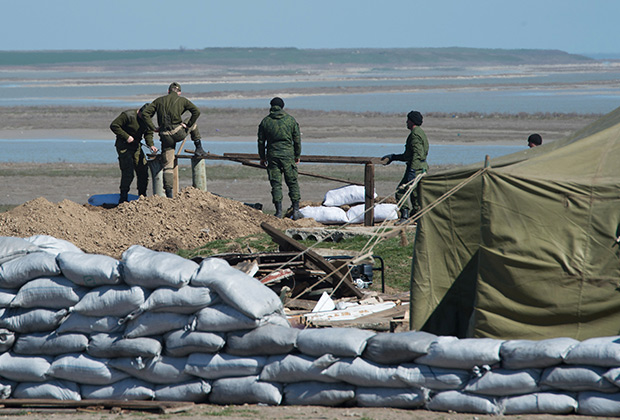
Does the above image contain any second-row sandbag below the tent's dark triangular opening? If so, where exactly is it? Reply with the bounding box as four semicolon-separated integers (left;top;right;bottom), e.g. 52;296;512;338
395;364;471;391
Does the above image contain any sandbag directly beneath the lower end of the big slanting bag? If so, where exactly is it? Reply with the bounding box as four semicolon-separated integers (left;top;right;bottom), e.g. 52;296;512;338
225;324;299;356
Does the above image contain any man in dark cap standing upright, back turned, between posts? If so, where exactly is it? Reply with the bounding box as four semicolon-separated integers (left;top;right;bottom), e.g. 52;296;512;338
258;97;303;220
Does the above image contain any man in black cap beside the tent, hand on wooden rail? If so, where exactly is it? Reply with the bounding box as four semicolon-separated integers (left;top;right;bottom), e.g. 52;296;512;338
383;111;428;223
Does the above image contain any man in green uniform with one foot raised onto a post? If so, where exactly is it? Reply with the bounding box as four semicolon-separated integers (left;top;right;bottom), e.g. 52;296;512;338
142;82;207;198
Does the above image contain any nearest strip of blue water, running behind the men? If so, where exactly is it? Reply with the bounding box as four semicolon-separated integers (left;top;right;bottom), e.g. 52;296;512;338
0;139;525;165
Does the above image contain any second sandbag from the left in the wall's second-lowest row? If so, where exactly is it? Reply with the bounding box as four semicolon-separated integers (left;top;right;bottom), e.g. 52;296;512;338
47;353;129;385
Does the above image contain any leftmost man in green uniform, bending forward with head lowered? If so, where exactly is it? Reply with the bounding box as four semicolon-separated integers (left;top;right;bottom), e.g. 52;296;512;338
110;104;157;204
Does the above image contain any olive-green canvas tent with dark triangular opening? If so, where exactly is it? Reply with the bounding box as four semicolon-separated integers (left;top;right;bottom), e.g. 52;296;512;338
411;108;620;340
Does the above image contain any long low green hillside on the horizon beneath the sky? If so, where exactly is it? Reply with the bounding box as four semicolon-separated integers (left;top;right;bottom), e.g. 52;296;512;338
0;47;596;68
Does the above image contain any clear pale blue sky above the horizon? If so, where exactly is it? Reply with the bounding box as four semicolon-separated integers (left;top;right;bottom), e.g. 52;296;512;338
0;0;620;55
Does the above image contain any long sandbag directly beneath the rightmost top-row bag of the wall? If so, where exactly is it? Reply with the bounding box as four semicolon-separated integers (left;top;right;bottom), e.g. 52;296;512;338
540;365;618;392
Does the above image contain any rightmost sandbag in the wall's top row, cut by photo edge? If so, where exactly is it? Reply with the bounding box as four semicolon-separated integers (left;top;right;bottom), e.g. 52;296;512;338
564;335;620;367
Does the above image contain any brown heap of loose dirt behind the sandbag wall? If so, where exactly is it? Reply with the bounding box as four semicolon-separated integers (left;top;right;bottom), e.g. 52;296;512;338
0;187;318;259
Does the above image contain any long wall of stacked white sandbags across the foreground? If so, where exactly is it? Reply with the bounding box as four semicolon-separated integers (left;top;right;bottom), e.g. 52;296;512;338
0;235;620;416
